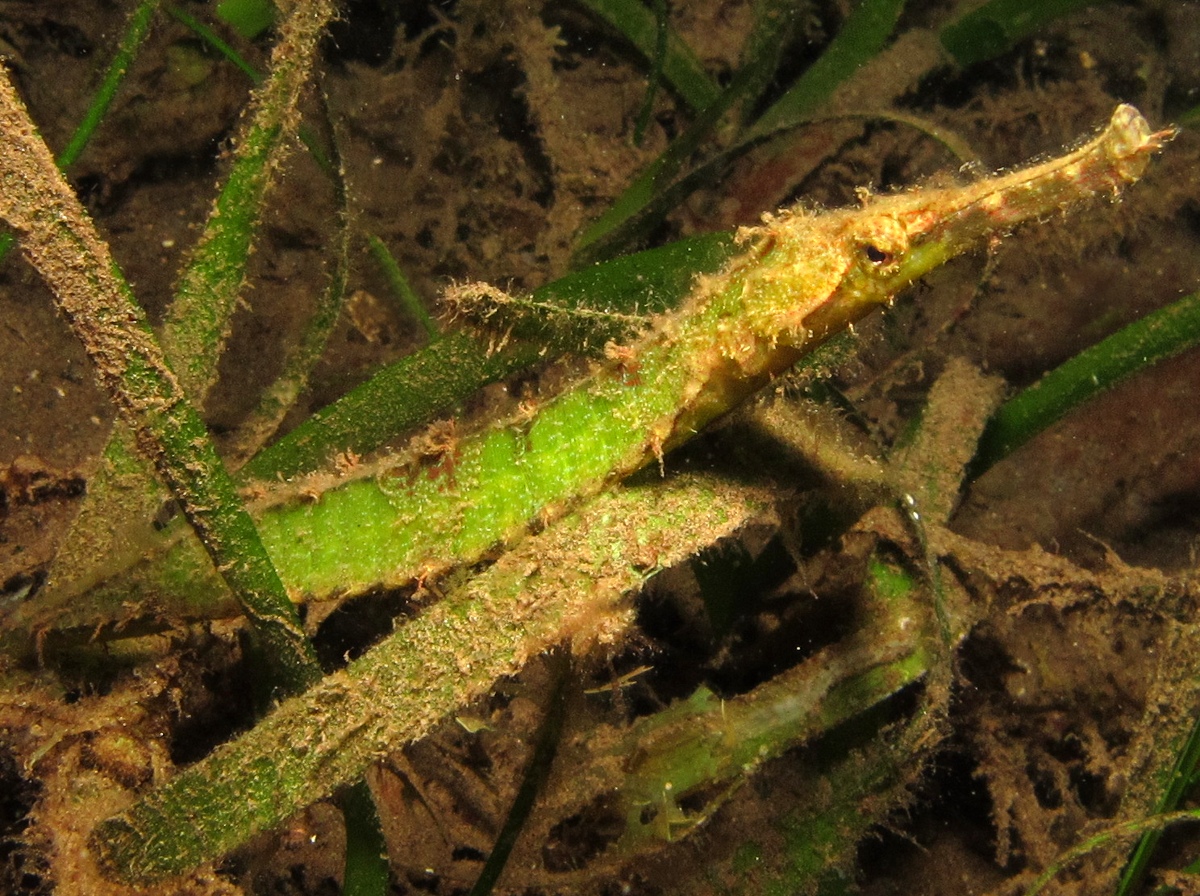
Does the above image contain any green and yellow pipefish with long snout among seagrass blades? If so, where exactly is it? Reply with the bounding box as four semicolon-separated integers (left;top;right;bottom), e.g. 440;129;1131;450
39;106;1169;614
